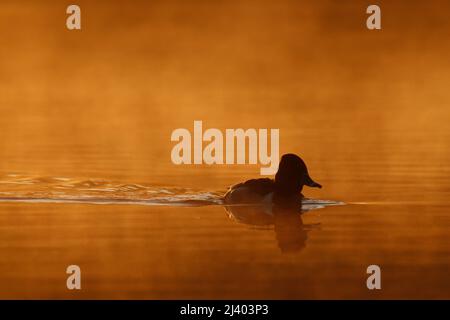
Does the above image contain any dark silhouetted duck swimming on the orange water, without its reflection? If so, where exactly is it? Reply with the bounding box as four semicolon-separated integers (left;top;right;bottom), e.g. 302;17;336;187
223;153;322;205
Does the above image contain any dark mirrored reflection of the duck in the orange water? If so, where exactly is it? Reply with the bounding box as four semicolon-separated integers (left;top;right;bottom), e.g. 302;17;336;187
225;198;320;253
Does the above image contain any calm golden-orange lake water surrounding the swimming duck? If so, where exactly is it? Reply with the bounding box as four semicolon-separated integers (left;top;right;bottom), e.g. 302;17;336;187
0;1;450;299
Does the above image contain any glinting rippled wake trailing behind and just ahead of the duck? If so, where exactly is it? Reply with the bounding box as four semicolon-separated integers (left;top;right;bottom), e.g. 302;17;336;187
0;174;341;210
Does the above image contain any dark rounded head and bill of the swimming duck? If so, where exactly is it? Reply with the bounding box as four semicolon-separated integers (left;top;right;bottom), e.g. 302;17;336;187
275;153;322;197
